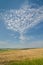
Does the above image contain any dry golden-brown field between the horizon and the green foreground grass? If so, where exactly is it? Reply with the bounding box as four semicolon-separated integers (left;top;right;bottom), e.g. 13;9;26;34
0;48;43;62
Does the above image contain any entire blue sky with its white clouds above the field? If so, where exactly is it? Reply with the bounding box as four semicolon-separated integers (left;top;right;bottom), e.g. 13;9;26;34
0;0;43;48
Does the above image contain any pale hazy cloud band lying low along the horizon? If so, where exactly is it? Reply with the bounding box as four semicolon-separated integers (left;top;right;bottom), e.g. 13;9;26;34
0;40;43;48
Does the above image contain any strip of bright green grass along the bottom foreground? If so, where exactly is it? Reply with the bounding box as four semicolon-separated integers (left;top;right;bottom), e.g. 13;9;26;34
2;59;43;65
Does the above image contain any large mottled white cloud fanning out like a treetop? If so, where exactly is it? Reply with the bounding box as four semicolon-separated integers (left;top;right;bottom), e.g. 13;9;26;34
1;1;43;39
